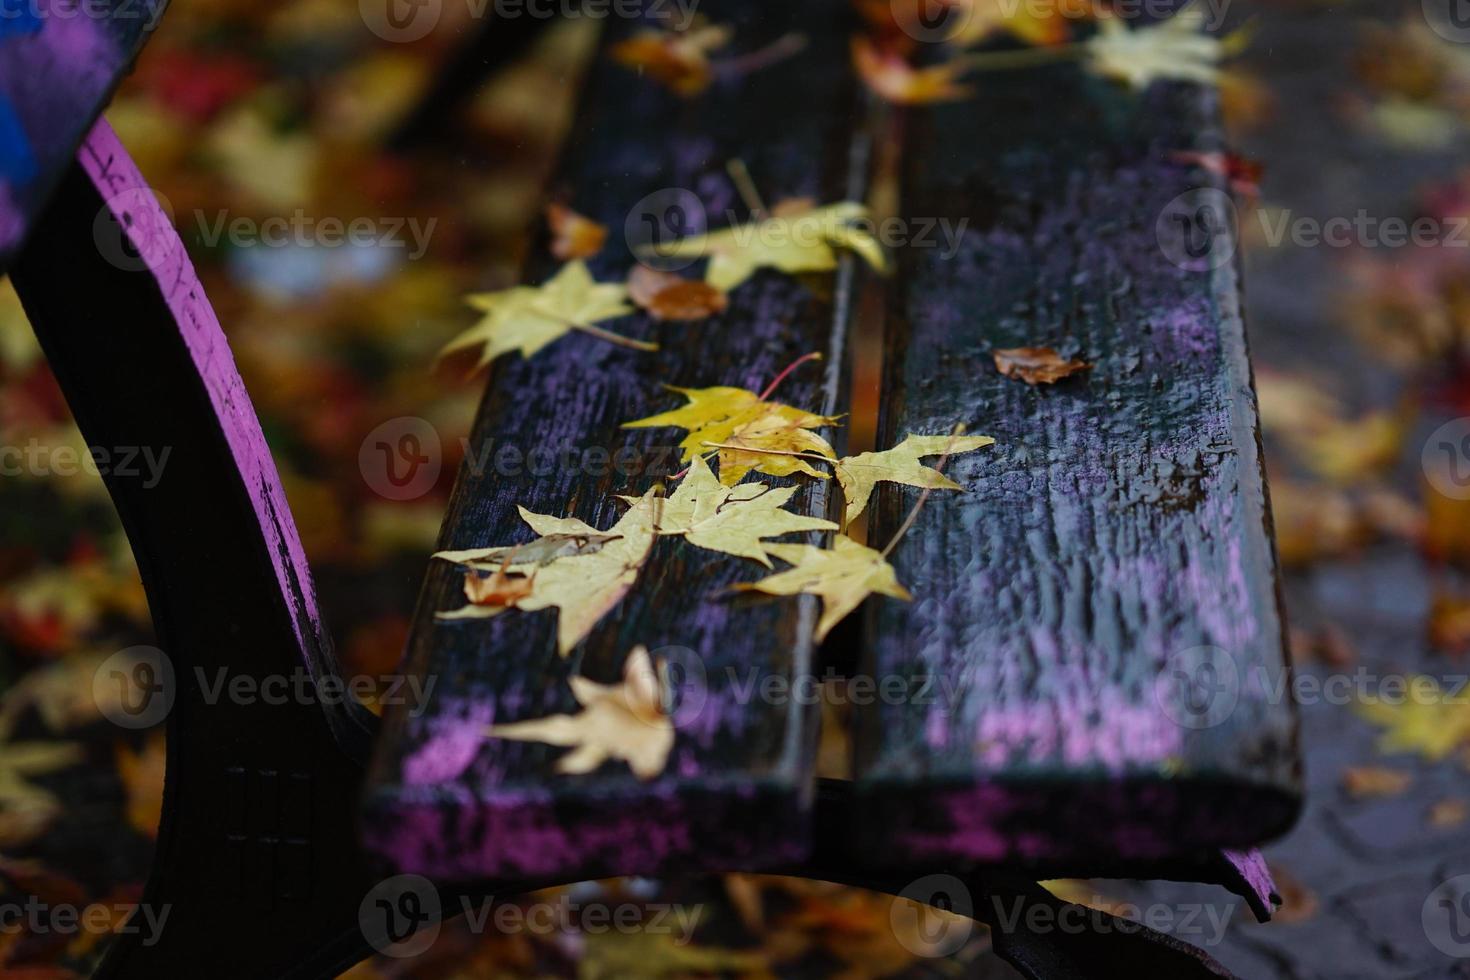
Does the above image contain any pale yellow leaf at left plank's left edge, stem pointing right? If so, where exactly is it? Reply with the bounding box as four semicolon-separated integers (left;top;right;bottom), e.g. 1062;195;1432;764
440;262;643;370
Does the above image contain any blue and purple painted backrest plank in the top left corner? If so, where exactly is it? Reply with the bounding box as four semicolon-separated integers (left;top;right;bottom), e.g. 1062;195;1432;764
0;0;166;272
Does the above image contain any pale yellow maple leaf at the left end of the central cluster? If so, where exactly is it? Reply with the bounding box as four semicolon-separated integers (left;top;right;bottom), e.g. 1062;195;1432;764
435;491;663;657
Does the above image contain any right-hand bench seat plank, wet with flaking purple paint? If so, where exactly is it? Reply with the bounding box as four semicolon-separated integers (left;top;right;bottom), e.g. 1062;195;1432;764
854;57;1299;862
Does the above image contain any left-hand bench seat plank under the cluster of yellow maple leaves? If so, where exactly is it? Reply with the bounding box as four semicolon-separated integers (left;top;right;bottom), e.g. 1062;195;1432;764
365;0;861;880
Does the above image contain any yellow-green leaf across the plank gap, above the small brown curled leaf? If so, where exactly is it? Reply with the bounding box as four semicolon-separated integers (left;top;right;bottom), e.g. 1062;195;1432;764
639;201;888;292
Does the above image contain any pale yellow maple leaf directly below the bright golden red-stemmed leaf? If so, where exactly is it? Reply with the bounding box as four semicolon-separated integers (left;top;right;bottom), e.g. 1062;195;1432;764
643;455;836;567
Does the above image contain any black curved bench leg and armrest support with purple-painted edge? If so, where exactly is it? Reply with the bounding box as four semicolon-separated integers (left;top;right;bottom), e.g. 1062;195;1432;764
13;123;370;980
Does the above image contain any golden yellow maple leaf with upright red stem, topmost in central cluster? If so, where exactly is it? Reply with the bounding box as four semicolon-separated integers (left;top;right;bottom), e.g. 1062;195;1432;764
623;386;836;486
